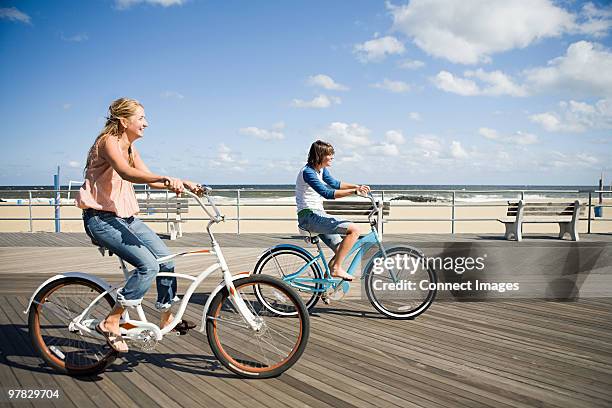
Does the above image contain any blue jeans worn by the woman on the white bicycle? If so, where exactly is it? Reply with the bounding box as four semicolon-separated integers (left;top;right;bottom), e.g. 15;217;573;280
83;211;180;310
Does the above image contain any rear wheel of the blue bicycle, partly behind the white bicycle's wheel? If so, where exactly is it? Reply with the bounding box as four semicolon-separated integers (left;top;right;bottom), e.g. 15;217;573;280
253;247;323;315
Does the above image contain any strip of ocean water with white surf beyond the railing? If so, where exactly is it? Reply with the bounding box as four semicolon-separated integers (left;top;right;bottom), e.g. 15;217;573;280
0;184;597;203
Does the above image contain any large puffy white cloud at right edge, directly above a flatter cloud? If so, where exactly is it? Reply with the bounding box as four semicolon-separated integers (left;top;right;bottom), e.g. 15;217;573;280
524;41;612;96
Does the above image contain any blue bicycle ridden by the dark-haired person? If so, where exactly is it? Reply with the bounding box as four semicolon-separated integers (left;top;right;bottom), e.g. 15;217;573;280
253;194;437;319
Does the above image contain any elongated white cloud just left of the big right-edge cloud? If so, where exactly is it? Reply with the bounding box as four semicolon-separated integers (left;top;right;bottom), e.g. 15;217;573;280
433;69;527;96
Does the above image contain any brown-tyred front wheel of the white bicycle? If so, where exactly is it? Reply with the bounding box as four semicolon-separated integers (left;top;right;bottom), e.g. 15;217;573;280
206;275;310;378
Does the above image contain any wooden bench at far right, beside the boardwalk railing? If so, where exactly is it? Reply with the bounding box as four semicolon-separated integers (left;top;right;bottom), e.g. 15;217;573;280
498;200;585;241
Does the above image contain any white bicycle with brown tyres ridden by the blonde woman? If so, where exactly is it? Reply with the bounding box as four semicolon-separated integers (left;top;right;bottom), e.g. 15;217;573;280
24;187;310;378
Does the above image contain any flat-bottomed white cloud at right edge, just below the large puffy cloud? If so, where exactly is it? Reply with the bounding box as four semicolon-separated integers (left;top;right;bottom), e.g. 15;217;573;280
529;98;612;132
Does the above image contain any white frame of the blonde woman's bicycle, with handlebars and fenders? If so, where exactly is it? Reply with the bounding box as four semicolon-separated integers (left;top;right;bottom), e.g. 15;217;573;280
24;190;261;341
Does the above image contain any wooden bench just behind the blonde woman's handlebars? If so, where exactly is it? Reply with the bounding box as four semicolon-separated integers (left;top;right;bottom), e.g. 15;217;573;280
138;197;189;240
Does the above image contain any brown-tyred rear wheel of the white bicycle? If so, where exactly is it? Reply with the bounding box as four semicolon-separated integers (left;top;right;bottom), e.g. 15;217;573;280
28;277;117;376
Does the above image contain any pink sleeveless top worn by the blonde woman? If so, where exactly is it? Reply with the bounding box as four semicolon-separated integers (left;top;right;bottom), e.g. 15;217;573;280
75;139;140;218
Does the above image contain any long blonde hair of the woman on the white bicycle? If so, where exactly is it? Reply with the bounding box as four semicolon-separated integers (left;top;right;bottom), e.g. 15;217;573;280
84;98;143;173
